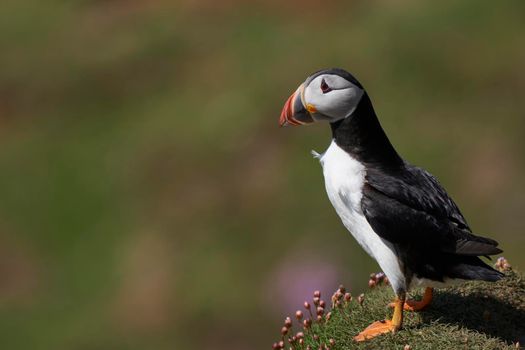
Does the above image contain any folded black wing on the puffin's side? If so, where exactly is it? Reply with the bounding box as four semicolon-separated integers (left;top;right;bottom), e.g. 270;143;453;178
361;164;502;256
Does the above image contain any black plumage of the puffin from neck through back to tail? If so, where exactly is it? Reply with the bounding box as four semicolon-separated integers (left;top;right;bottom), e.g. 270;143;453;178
331;89;502;281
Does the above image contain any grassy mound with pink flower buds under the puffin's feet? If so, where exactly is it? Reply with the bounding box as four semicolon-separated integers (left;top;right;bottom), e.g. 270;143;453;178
274;271;525;350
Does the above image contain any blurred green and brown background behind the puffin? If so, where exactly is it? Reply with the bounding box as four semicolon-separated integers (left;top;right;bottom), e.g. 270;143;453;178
0;0;525;350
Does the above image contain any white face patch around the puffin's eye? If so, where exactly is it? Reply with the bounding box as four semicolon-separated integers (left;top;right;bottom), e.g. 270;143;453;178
304;74;364;122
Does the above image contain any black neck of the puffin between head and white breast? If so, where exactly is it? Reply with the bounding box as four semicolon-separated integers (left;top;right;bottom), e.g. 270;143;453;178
330;92;403;168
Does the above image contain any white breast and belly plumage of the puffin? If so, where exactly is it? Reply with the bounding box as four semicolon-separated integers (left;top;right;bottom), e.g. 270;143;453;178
319;141;407;290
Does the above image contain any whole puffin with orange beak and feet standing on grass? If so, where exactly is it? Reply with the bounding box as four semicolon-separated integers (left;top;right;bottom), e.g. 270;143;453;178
279;68;503;342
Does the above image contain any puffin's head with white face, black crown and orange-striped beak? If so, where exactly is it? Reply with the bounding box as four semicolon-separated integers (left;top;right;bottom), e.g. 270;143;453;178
279;68;365;126
